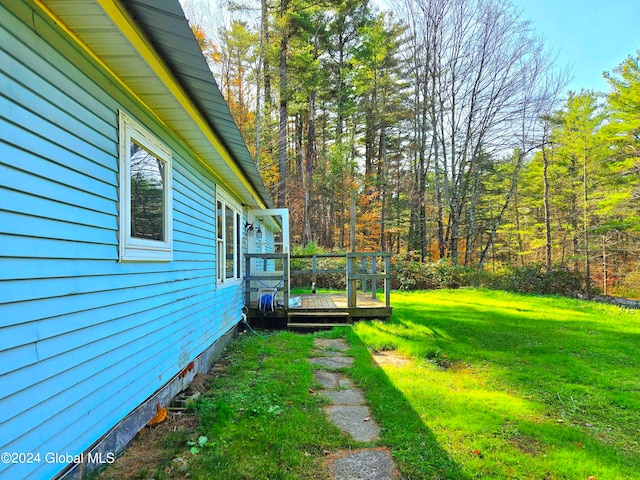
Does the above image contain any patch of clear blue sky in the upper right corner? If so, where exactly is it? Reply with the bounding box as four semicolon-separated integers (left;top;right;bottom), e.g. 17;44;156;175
512;0;640;92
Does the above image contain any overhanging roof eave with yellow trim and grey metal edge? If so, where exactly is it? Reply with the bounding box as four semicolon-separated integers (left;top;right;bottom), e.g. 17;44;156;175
35;0;272;208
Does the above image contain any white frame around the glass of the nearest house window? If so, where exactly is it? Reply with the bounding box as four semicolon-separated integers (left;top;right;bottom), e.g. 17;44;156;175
118;111;173;262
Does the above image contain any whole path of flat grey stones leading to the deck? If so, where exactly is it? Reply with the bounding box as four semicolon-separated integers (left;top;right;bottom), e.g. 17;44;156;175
309;338;398;480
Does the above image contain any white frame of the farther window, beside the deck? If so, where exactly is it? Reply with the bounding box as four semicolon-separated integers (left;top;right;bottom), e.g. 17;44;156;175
215;187;243;287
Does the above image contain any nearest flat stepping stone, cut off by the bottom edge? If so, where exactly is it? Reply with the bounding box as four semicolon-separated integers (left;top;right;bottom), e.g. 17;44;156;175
329;449;398;480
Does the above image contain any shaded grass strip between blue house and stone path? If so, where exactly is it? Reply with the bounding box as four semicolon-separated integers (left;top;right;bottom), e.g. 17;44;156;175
181;332;354;480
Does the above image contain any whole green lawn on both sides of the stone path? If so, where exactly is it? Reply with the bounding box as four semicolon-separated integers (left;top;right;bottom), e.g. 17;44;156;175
115;289;640;480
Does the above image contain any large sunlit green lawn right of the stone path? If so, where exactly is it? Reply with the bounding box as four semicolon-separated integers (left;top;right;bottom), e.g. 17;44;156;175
349;289;640;480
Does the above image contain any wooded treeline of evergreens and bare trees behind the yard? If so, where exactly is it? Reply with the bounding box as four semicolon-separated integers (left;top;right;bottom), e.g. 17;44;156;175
184;0;640;293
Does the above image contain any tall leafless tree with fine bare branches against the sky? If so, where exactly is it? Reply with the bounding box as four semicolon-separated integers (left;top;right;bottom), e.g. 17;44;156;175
404;0;563;263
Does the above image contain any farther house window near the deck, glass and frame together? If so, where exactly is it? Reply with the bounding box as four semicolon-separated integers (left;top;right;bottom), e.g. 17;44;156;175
216;191;242;284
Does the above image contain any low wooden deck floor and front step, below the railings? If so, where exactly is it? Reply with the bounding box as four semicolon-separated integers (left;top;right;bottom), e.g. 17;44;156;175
248;292;392;328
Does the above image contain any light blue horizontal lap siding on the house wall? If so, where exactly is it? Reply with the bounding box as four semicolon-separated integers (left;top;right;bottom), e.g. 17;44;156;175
0;6;242;478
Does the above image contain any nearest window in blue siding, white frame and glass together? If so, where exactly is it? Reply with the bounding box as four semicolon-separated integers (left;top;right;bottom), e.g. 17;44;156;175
119;112;173;261
